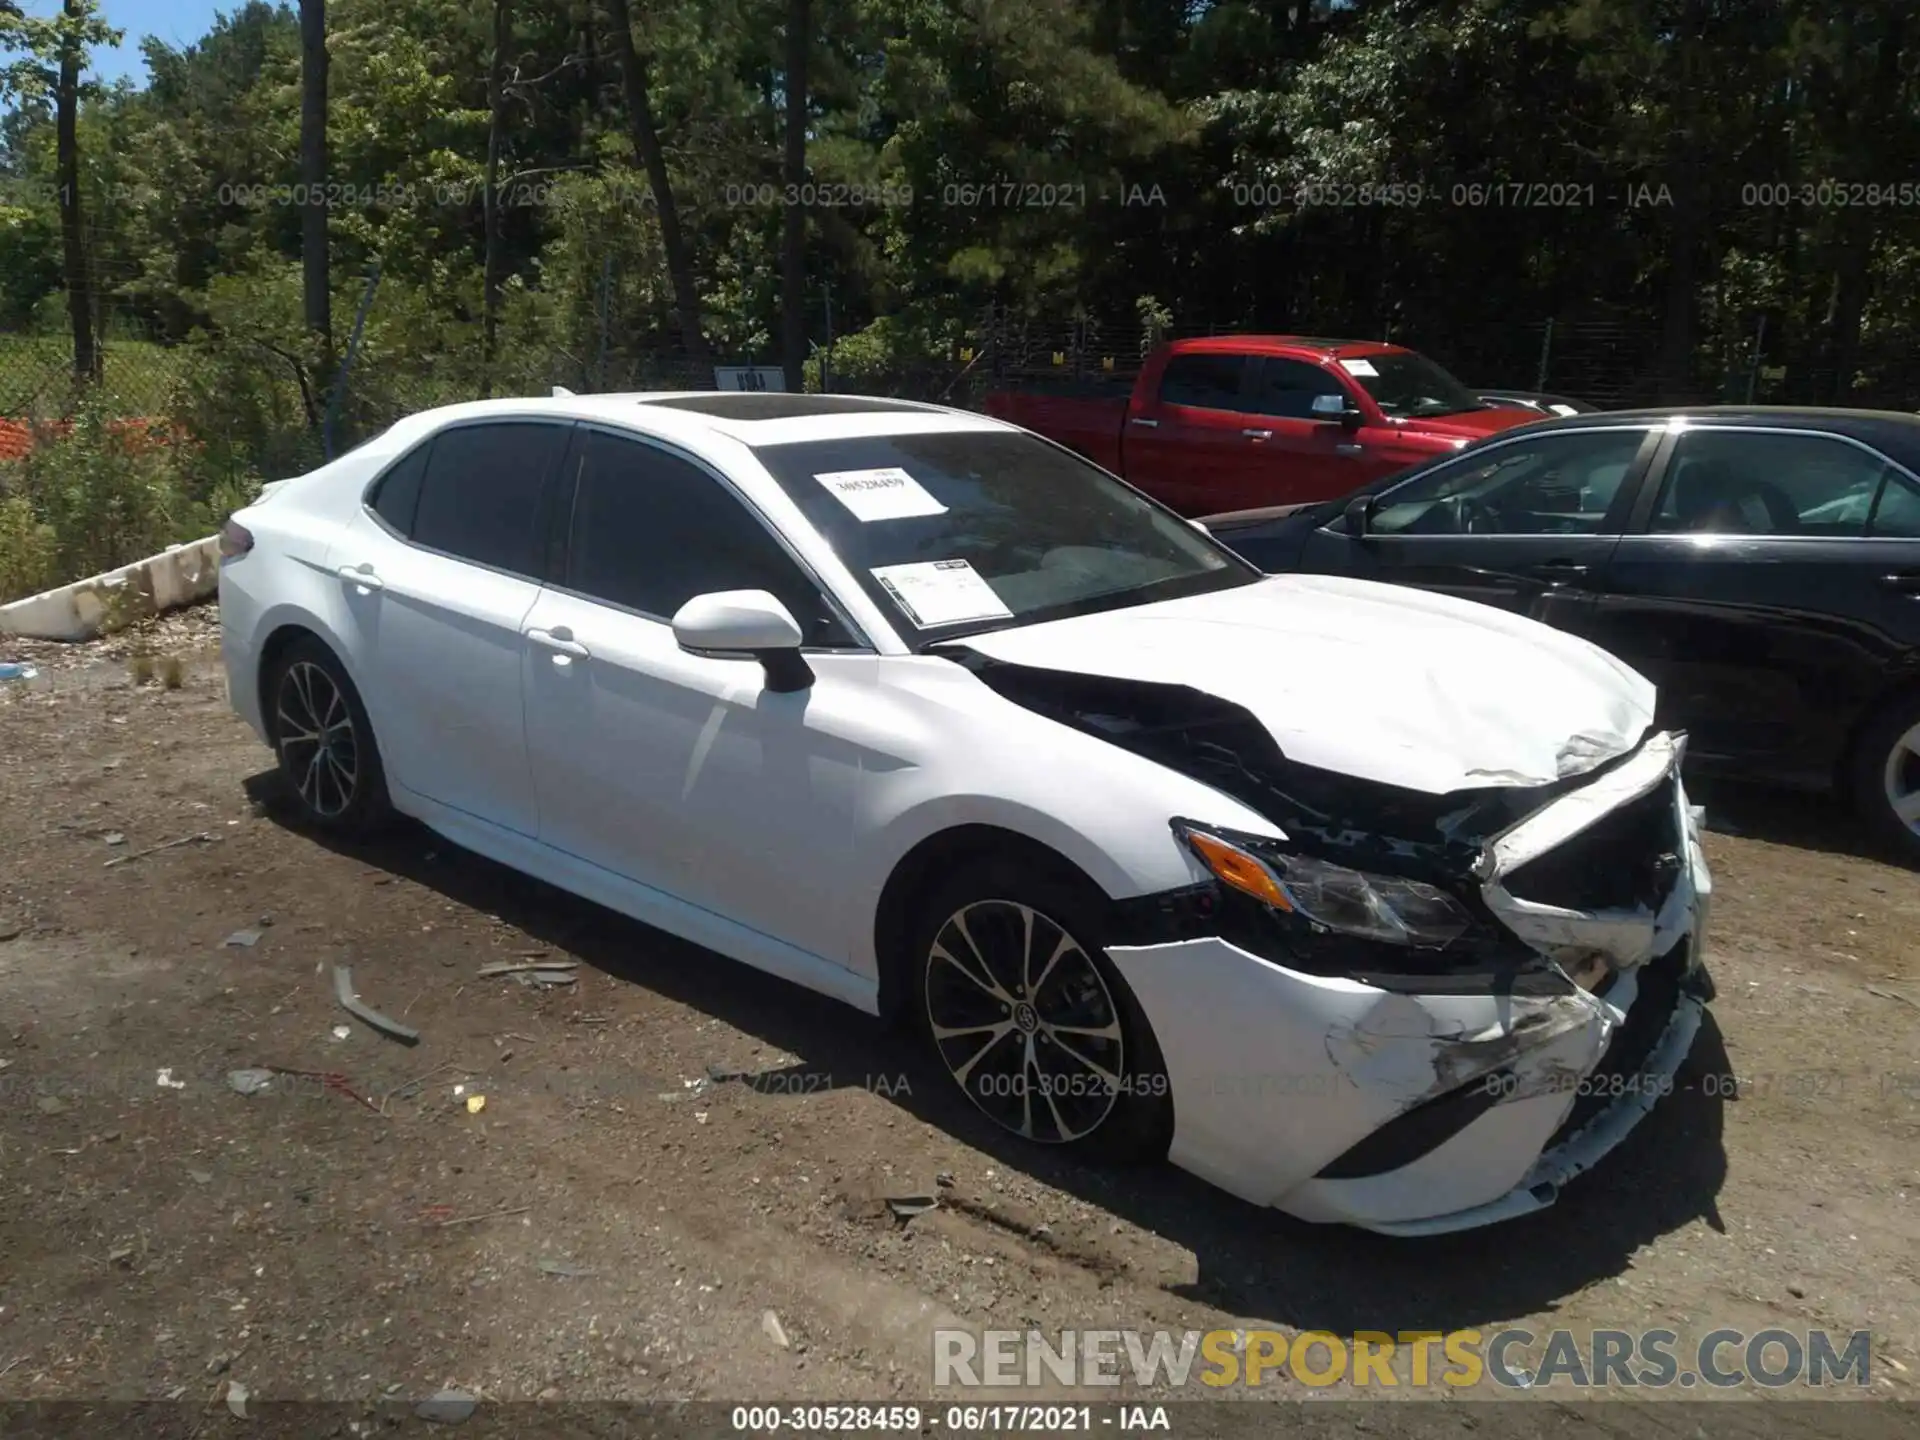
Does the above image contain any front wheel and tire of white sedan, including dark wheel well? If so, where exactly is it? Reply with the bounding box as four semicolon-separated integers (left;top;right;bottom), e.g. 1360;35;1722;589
908;860;1173;1160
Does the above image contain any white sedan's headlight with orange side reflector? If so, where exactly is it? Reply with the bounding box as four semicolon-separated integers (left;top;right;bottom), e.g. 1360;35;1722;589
1173;820;1473;948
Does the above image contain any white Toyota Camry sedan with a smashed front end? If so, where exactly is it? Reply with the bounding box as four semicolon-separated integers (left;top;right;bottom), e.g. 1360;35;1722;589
221;394;1711;1235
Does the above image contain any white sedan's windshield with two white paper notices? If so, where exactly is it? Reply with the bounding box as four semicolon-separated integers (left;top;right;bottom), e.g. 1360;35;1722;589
755;430;1260;639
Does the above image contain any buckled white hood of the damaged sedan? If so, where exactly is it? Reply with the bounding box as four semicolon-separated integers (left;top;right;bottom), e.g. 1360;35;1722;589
960;574;1653;795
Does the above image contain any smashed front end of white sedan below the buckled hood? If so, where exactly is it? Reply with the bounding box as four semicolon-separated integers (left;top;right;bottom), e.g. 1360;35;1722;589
962;657;1711;1235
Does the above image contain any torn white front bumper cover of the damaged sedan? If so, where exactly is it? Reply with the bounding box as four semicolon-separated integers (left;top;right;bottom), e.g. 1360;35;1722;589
1108;735;1713;1235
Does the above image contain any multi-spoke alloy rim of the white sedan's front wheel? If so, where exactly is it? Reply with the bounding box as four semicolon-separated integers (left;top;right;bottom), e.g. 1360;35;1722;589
925;900;1127;1144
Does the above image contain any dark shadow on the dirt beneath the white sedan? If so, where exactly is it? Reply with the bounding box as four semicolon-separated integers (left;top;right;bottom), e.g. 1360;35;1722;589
248;772;1732;1332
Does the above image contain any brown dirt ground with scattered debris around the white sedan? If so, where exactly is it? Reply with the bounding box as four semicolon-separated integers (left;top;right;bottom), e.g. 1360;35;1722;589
0;609;1920;1432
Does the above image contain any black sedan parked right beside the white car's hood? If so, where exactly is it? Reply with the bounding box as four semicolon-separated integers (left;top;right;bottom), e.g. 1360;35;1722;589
1204;407;1920;860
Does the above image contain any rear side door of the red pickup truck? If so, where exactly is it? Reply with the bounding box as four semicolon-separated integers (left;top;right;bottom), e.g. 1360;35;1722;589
1119;351;1260;516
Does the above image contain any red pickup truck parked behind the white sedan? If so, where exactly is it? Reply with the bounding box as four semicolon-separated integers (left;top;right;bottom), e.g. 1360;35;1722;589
987;336;1540;516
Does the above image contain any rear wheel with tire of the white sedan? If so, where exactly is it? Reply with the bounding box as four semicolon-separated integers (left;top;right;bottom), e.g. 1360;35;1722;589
263;636;394;835
